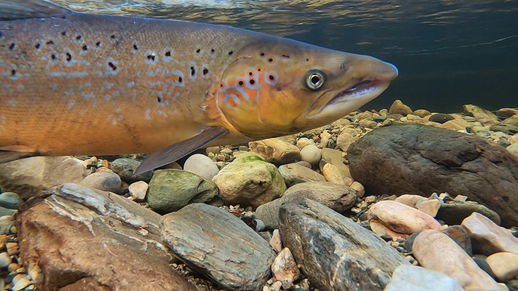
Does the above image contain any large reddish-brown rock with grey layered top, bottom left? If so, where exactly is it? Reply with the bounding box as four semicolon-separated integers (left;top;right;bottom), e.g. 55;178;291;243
17;184;195;290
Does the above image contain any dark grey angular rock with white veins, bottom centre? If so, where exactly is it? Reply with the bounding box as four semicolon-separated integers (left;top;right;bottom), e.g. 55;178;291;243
279;199;408;291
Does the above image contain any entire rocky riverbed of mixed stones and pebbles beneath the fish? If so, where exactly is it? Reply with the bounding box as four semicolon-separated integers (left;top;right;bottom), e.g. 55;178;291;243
0;100;518;291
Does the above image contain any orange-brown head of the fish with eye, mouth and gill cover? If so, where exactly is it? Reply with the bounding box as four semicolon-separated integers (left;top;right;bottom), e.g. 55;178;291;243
216;38;398;138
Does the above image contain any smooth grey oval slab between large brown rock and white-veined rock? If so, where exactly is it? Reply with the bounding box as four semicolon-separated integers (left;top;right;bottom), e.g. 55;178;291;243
161;203;275;290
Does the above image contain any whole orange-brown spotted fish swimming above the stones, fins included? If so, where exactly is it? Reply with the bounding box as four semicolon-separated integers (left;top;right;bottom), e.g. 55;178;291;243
0;0;398;173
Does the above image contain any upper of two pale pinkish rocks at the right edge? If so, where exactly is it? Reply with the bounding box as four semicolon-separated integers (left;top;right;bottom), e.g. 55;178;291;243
462;212;518;255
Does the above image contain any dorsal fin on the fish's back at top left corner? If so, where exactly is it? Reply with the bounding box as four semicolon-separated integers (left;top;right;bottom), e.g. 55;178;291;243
0;0;71;20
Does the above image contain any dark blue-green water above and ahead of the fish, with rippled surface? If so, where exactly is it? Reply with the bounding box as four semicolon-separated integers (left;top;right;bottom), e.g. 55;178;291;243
49;0;518;112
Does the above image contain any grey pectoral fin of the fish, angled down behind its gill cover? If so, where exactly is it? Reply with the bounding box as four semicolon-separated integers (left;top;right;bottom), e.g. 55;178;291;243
133;127;228;175
